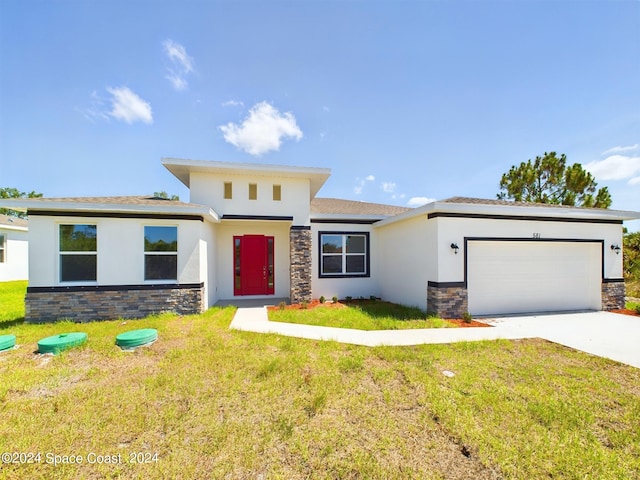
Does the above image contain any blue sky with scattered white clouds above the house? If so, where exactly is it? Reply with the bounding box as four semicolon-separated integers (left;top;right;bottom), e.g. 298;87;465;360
0;0;640;225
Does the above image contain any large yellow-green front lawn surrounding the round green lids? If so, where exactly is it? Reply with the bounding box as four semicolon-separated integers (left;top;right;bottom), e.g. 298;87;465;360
0;284;640;480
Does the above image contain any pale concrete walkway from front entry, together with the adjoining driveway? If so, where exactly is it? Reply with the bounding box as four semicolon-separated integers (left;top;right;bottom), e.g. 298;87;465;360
229;306;640;368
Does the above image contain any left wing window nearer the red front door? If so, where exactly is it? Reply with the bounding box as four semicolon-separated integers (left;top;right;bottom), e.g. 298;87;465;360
144;226;178;281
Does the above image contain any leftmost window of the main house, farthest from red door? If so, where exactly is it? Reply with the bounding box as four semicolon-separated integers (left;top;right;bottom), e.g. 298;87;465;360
59;225;98;282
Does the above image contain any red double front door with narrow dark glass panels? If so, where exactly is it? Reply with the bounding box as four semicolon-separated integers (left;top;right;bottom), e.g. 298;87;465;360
233;235;275;295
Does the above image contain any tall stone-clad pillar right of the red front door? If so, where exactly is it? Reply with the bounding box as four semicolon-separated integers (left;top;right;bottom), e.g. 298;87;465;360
289;227;311;303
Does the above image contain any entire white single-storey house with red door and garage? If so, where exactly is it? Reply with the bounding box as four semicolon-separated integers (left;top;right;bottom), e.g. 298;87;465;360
0;158;640;321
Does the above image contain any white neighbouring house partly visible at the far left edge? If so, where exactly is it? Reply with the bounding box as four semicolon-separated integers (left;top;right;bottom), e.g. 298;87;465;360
0;214;29;282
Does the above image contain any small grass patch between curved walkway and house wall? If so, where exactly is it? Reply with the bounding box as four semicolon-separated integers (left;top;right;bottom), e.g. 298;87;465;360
269;300;454;330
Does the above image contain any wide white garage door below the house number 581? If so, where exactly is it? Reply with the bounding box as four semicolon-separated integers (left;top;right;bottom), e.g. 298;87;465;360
467;240;602;315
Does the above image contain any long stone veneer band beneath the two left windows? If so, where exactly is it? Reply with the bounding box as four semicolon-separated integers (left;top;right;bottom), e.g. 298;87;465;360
25;284;204;323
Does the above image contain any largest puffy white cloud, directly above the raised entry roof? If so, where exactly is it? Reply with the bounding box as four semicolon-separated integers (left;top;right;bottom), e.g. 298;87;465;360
218;102;302;155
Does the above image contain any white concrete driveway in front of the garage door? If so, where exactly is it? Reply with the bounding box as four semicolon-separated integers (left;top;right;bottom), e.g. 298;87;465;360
485;312;640;368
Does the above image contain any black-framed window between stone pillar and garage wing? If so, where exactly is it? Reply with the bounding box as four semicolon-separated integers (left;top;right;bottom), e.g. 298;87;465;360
320;232;369;277
